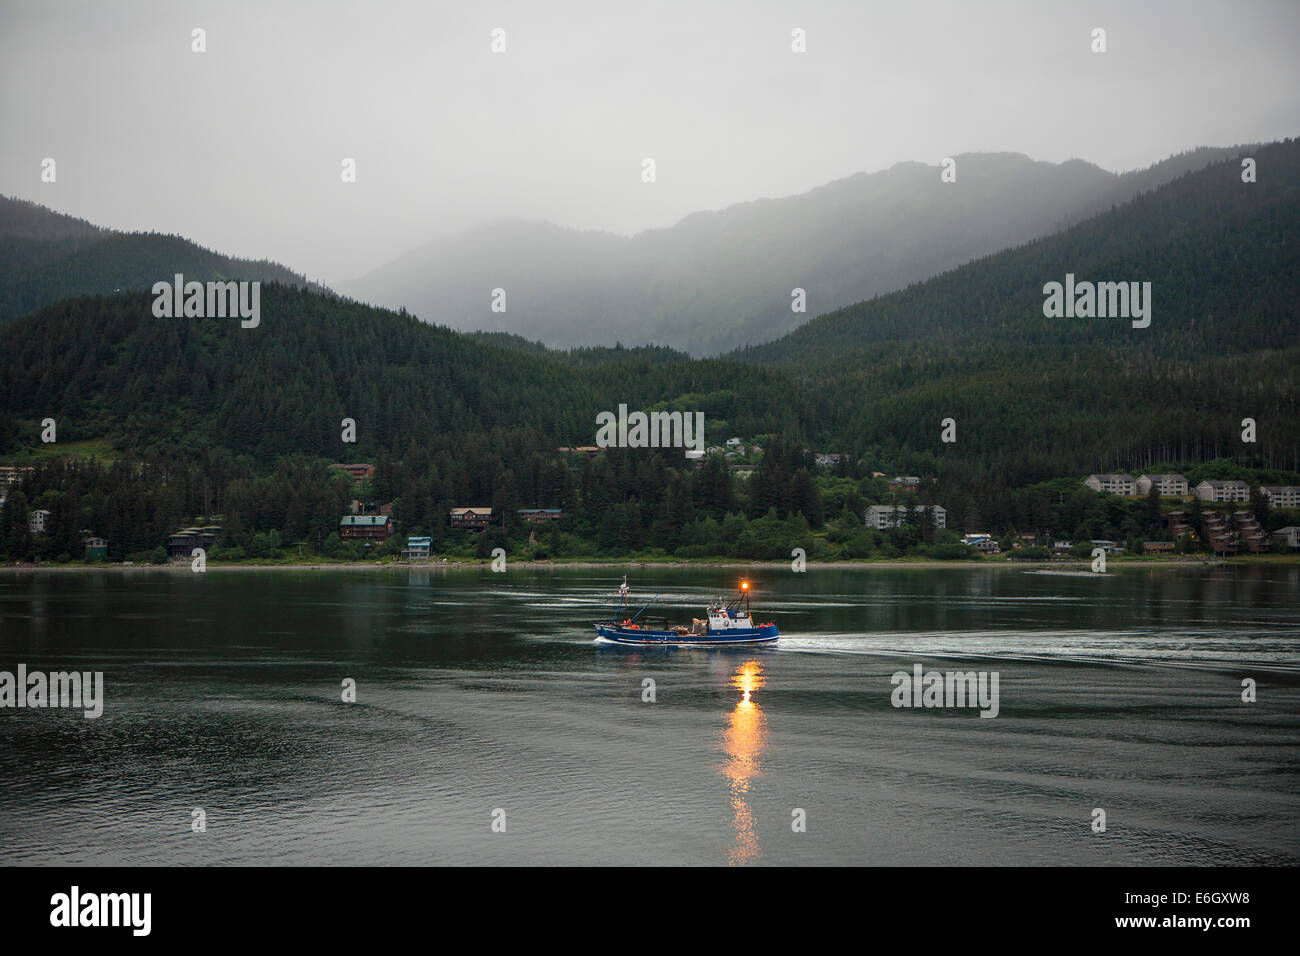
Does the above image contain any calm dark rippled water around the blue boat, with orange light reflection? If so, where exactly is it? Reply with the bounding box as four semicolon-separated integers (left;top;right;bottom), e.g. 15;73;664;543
0;566;1300;865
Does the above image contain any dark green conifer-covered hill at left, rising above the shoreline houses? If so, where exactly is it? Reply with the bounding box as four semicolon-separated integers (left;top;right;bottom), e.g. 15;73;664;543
0;284;802;463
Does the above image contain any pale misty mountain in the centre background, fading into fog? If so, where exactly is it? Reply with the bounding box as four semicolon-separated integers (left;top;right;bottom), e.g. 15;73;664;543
337;150;1248;355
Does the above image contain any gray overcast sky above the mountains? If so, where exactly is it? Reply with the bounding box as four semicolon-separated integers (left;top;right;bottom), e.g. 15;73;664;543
0;0;1300;282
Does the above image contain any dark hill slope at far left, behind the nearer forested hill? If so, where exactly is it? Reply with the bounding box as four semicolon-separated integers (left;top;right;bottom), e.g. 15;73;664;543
0;196;321;323
